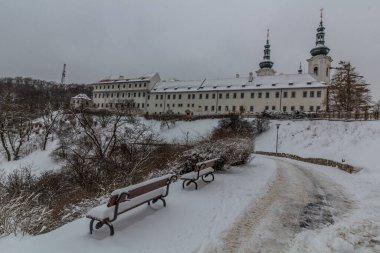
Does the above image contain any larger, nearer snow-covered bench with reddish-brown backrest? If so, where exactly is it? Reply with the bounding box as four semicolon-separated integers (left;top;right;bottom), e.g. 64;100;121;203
86;174;177;235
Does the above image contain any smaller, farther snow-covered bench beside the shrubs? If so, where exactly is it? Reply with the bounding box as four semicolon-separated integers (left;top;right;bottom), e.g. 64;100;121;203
181;158;219;190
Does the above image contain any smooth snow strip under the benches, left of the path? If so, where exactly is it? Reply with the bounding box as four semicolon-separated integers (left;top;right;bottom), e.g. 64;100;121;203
0;158;276;253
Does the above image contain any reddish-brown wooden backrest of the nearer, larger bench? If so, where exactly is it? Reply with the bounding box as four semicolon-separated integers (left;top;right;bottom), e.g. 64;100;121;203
107;178;171;207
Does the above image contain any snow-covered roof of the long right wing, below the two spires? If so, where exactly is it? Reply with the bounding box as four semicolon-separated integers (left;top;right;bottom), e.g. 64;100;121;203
152;74;326;92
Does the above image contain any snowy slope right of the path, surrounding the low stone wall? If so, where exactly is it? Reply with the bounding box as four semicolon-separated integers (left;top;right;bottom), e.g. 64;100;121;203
255;121;380;252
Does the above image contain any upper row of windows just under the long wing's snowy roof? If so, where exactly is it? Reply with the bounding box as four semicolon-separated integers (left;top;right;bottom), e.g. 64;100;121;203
156;90;322;100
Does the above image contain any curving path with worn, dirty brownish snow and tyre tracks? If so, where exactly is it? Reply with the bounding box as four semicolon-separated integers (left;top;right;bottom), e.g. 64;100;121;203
222;157;352;252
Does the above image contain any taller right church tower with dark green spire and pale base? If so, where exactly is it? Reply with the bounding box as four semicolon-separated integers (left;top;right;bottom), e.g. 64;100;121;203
307;9;333;84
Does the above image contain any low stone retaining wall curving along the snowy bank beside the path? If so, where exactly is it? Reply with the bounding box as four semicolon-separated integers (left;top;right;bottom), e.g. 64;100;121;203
255;151;354;173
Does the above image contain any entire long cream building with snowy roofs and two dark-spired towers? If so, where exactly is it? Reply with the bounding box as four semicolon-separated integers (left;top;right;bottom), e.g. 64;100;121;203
93;14;332;115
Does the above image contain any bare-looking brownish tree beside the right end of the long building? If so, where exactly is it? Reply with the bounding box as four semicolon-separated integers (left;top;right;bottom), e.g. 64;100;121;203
328;61;371;112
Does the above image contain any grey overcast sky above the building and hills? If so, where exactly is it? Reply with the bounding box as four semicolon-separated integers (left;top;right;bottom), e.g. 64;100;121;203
0;0;380;98
